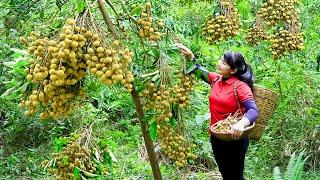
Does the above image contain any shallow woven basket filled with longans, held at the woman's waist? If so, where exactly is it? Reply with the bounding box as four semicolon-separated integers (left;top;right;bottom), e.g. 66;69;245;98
209;116;255;141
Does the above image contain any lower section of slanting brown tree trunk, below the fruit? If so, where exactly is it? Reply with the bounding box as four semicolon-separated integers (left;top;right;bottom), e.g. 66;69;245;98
131;87;162;180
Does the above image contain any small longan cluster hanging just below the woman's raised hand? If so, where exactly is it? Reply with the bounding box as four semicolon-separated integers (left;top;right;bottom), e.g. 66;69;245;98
173;71;195;108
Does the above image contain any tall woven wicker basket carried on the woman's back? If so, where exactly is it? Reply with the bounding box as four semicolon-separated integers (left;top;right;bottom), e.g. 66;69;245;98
249;85;277;140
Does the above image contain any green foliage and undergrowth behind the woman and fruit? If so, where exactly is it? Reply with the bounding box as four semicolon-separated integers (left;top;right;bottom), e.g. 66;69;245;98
0;0;320;179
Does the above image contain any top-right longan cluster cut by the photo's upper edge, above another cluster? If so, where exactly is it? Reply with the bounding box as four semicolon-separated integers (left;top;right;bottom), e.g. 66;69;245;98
257;0;299;26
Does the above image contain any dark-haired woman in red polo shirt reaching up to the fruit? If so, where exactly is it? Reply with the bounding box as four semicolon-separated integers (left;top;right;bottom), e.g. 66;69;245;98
177;44;259;180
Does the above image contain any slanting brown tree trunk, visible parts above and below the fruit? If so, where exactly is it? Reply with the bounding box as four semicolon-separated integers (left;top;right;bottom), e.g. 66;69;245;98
98;0;162;180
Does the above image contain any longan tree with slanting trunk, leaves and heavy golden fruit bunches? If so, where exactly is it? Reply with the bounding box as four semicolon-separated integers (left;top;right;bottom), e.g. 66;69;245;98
20;0;200;179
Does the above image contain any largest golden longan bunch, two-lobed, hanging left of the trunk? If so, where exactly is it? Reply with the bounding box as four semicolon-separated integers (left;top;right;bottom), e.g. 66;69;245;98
20;13;133;119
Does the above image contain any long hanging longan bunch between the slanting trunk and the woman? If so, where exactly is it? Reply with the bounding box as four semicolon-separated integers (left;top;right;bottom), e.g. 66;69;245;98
140;58;195;167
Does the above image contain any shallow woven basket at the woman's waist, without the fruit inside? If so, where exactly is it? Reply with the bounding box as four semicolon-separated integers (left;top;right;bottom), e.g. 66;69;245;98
210;122;255;141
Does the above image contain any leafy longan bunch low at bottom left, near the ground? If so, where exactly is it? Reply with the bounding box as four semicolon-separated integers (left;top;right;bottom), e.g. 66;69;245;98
41;133;109;180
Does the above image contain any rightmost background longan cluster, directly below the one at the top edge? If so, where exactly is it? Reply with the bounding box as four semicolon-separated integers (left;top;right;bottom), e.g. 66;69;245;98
270;30;303;59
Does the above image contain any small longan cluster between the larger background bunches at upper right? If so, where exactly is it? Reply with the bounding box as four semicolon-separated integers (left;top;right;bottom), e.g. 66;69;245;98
245;26;269;45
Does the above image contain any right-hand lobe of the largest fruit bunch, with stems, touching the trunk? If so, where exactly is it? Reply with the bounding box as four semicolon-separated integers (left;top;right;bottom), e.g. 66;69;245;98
78;12;134;92
